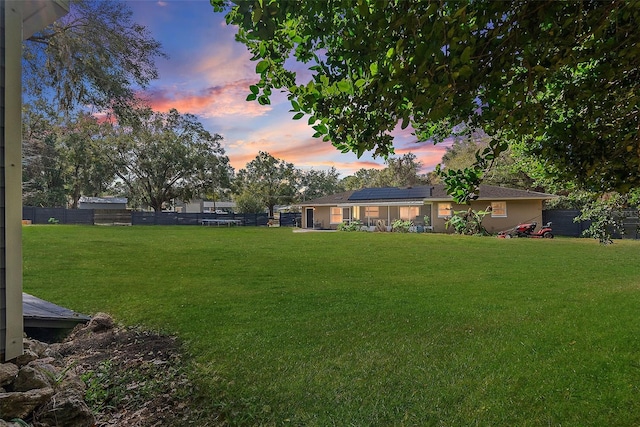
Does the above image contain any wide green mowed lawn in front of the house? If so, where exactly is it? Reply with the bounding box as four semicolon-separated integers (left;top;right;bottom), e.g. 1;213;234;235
23;226;640;426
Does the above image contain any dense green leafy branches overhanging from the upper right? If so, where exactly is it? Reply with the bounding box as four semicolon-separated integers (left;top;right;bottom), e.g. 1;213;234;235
211;0;640;202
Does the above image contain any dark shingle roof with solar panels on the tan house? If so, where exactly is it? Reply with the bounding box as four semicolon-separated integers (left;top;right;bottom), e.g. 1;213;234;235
299;184;557;206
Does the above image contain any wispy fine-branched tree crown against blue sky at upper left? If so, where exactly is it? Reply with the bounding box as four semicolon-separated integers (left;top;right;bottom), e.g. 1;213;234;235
23;0;165;114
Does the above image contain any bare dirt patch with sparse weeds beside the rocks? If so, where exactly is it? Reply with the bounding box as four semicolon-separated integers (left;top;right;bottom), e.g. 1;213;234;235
55;314;224;427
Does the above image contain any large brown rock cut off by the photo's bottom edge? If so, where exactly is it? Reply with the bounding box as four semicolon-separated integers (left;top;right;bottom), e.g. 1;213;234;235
34;388;96;427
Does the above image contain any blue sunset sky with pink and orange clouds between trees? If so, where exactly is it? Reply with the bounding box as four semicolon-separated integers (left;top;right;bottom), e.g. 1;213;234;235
127;0;452;177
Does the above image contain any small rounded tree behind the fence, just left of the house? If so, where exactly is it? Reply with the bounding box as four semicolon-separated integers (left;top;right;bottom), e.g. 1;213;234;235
235;151;298;216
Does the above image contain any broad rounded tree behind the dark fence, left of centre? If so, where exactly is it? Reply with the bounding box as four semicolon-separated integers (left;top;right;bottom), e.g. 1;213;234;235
104;108;228;211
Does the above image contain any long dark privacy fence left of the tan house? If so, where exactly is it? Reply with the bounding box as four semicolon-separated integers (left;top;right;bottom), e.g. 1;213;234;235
22;206;301;227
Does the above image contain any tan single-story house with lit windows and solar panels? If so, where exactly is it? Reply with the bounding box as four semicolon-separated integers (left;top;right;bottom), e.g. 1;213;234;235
300;185;556;233
